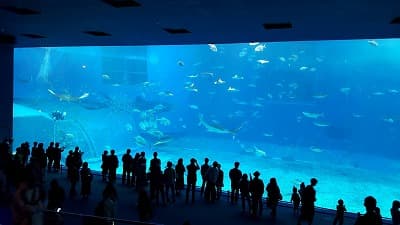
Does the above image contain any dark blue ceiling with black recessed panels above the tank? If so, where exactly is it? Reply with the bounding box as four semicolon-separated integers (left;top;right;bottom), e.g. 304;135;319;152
0;0;400;47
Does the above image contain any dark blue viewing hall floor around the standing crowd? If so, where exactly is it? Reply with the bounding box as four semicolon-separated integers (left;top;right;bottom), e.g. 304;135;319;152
0;173;390;225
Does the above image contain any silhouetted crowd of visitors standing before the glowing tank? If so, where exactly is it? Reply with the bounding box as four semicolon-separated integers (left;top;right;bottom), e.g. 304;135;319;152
0;139;400;225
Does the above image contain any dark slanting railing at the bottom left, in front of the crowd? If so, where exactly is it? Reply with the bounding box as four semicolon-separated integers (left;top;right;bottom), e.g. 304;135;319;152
44;210;163;225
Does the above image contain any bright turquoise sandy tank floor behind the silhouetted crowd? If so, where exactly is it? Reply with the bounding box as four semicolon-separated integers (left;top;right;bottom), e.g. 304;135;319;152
84;137;400;217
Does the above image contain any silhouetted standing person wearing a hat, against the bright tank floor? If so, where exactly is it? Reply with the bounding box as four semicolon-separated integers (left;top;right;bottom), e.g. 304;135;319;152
249;171;264;216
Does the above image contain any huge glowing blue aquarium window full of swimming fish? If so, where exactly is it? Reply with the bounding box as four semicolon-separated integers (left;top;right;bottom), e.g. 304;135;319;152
13;39;400;217
